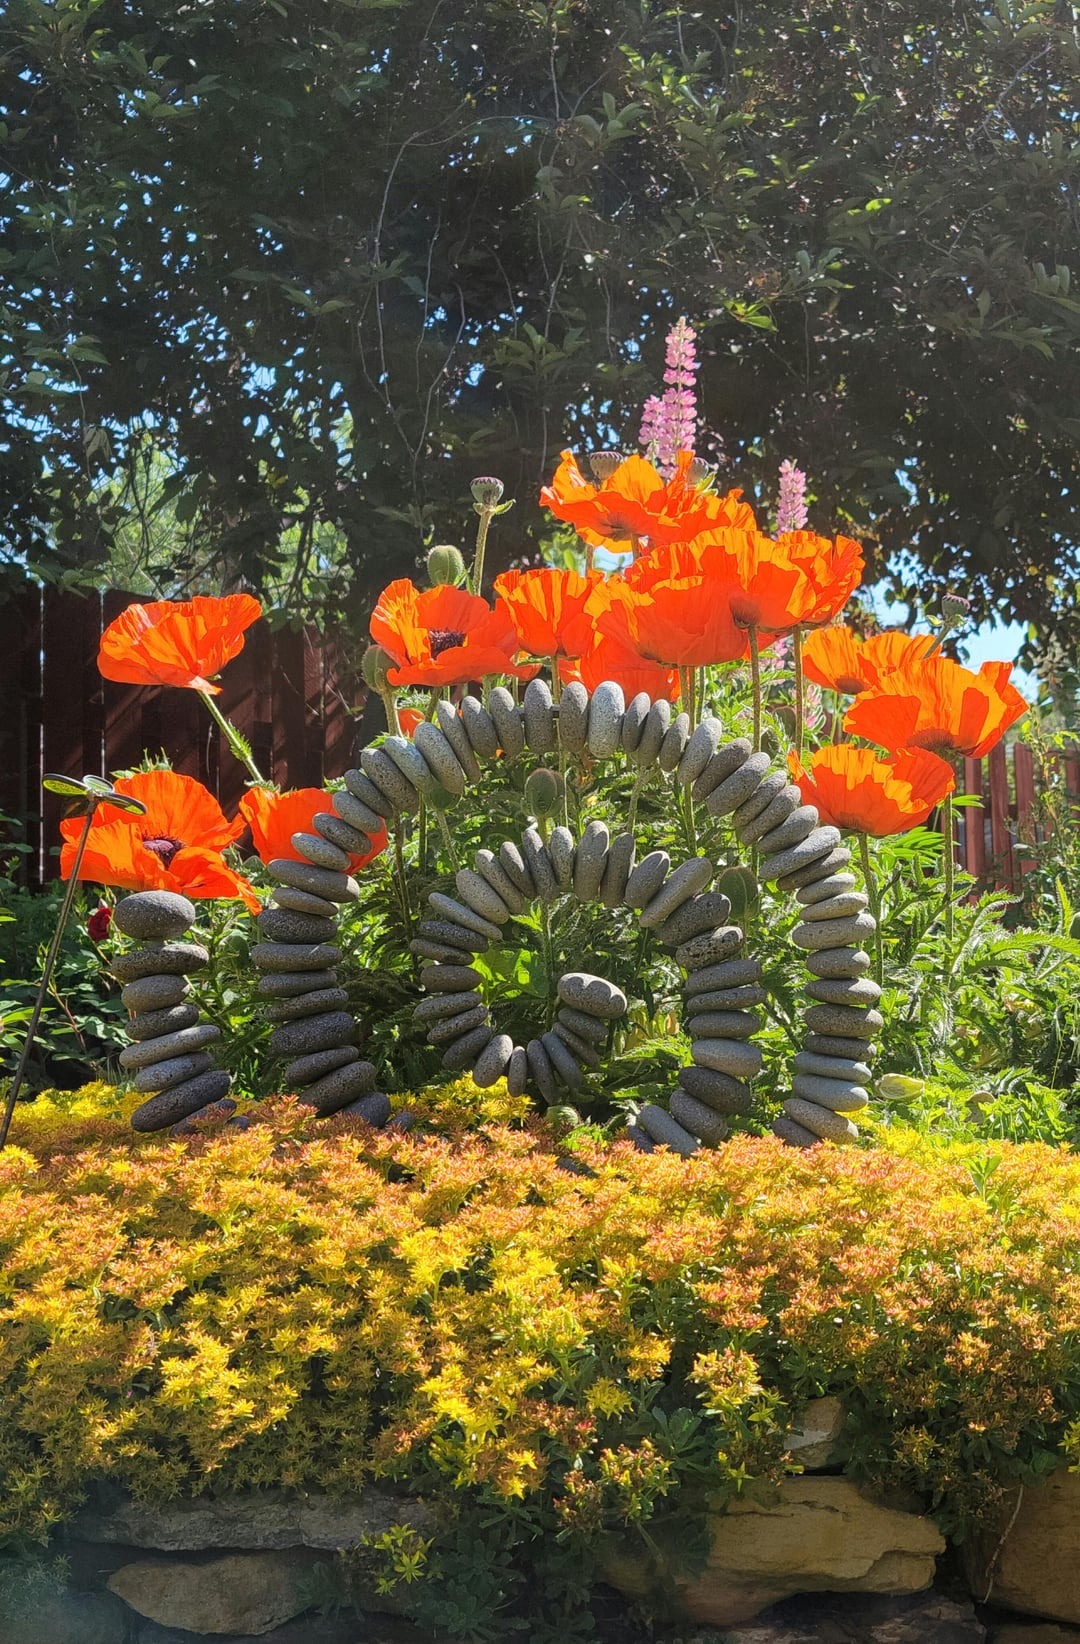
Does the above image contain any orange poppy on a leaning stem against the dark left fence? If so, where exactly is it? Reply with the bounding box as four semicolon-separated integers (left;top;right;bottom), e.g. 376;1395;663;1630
97;593;263;695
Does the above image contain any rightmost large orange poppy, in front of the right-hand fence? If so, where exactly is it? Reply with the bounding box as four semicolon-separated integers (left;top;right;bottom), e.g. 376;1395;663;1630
843;656;1027;760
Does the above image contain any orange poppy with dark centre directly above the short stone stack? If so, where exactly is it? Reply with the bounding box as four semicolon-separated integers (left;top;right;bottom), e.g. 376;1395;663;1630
61;771;260;912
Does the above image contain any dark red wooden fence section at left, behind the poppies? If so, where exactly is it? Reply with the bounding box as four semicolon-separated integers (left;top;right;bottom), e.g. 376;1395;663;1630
0;589;362;884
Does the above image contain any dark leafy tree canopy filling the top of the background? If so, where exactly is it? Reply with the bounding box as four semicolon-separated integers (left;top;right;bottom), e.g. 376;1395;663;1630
0;0;1080;633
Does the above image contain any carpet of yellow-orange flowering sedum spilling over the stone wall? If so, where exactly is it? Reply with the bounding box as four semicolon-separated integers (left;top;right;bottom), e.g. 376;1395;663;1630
0;1080;1080;1535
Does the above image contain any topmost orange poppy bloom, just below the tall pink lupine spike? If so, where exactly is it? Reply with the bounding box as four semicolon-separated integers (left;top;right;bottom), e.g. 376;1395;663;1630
539;450;753;551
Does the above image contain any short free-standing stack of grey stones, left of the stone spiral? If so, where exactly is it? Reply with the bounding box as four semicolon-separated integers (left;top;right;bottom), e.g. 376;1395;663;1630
112;891;233;1131
